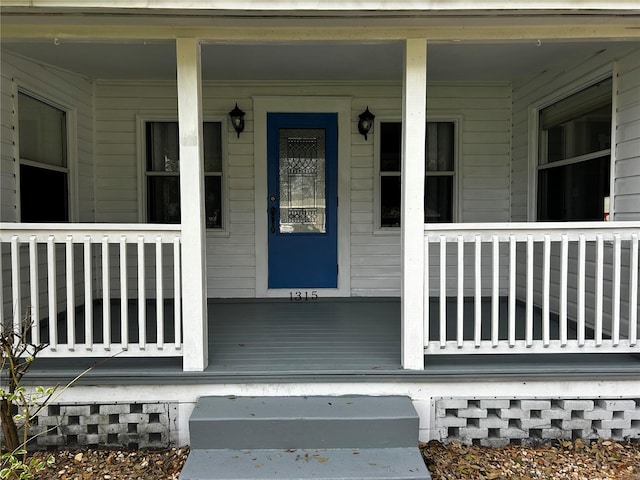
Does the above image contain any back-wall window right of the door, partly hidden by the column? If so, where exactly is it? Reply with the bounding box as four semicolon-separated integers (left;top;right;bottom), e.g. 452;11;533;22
378;122;456;227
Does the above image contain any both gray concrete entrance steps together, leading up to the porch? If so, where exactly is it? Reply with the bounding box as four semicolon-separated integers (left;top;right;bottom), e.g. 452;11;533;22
180;396;431;480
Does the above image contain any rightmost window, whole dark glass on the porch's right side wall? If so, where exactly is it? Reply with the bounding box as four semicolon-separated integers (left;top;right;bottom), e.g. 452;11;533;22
538;78;612;221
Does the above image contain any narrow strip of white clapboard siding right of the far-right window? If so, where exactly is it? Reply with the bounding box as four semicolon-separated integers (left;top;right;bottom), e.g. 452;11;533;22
614;50;640;220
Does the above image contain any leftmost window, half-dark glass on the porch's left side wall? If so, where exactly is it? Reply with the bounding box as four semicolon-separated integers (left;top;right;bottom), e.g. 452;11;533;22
18;92;69;222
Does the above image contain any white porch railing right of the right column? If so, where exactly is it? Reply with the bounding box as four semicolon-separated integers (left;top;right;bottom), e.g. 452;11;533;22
424;222;640;354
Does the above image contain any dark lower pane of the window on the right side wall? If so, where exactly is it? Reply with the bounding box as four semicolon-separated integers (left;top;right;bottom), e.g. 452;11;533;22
538;156;610;221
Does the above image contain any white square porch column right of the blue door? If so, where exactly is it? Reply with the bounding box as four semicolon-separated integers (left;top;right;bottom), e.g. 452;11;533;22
400;39;427;370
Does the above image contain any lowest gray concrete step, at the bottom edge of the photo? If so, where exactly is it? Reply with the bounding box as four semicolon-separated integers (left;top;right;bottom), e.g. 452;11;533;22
180;446;431;480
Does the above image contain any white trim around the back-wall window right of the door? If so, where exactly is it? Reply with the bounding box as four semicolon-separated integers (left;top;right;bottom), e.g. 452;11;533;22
373;115;463;232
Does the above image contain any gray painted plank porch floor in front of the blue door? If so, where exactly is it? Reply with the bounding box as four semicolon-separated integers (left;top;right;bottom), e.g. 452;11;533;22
29;298;640;384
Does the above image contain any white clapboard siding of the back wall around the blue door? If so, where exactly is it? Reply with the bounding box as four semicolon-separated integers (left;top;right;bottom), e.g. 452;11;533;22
96;81;511;297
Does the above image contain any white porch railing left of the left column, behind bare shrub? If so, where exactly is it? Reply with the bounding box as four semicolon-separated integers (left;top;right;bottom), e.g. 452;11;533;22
0;223;182;357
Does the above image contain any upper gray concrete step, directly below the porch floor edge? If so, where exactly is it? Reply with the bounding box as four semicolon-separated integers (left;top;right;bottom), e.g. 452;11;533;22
189;396;419;450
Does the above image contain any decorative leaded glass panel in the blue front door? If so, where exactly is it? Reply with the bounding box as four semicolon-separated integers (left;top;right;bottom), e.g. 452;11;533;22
279;128;327;233
